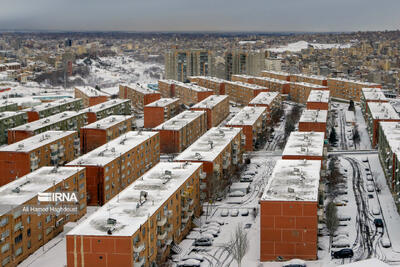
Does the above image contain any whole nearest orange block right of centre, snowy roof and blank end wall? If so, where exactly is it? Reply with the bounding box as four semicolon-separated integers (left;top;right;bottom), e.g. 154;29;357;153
260;160;321;261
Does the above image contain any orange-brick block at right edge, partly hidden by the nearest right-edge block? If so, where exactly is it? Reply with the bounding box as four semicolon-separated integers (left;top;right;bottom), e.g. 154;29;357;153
366;102;400;147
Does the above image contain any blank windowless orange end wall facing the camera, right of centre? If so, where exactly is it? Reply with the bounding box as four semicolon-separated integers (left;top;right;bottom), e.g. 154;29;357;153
260;200;318;261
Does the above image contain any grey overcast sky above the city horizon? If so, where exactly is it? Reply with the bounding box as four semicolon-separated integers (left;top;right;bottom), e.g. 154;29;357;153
0;0;400;32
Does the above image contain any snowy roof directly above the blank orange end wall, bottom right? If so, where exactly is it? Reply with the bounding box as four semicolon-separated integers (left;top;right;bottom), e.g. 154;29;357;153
261;160;321;202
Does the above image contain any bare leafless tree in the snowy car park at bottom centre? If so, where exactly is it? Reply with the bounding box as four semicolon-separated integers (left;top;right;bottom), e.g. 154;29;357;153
222;223;249;267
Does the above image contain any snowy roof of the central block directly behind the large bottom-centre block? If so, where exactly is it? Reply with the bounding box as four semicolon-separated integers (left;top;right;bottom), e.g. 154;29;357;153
175;127;242;162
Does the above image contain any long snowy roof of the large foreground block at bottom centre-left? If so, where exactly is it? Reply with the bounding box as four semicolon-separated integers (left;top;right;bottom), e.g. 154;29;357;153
67;162;202;236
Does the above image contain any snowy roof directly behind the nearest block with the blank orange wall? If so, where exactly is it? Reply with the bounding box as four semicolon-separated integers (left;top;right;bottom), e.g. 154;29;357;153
282;132;324;157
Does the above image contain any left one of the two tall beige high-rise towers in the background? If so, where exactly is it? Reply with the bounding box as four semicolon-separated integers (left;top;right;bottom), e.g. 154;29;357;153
165;48;215;82
